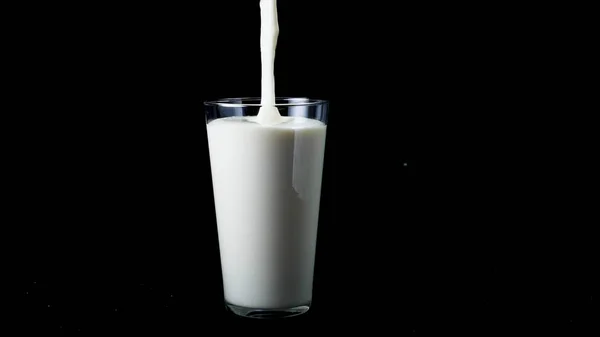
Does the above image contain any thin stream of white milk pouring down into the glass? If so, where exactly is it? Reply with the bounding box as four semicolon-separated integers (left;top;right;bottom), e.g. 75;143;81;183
257;0;282;125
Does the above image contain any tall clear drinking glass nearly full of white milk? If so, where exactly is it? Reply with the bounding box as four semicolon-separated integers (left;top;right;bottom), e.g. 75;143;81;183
204;98;329;318
